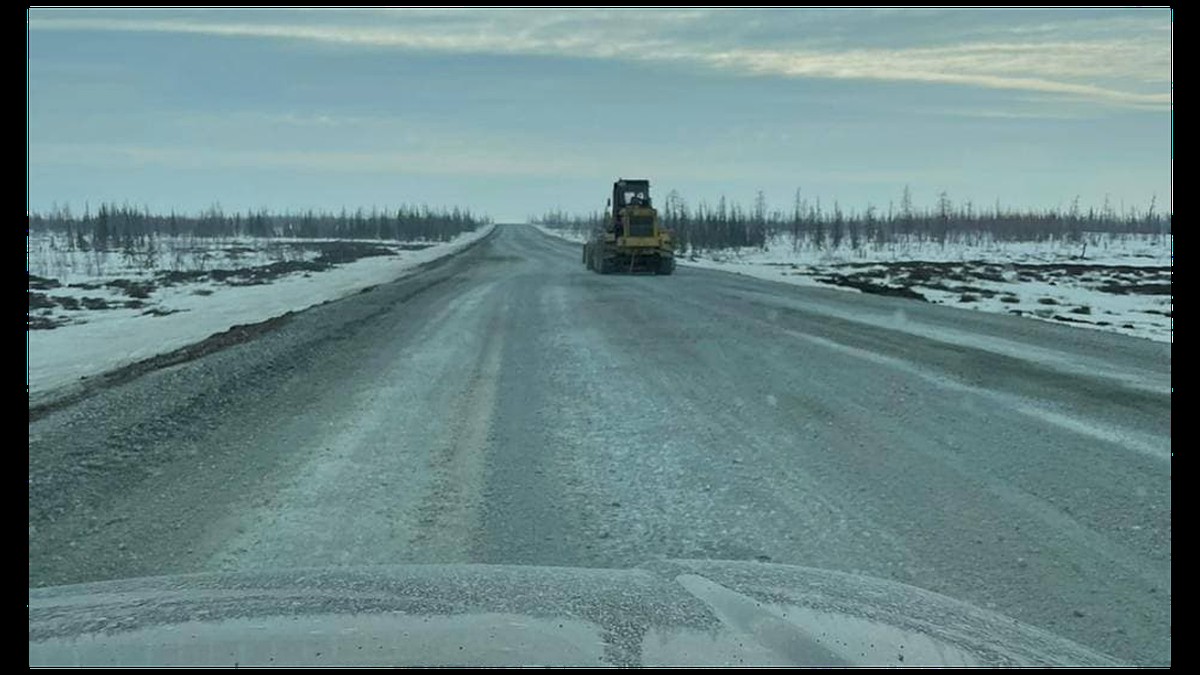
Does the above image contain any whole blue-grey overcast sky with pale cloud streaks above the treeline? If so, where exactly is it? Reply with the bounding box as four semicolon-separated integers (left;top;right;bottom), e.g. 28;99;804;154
28;8;1171;222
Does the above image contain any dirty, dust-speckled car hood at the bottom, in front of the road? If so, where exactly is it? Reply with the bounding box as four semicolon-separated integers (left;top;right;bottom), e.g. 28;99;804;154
29;561;1115;667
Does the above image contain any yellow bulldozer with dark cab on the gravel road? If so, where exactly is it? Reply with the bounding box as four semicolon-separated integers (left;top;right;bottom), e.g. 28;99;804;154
583;179;674;274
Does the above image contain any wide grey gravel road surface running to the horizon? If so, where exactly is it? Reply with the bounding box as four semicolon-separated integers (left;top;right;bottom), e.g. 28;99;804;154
29;226;1171;664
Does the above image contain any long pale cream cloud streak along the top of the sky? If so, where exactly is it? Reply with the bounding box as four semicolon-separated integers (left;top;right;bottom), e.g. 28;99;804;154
30;11;1170;109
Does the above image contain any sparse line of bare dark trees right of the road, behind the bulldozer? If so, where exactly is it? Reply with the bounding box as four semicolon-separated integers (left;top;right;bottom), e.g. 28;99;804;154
533;187;1171;251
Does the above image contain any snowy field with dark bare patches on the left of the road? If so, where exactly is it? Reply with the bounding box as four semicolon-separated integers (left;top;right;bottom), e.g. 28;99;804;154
26;226;493;400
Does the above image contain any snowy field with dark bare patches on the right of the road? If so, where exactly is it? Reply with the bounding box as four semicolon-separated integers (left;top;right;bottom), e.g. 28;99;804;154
536;226;1174;342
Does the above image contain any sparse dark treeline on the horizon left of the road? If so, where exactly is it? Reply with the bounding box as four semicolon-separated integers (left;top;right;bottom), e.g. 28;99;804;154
29;204;490;250
